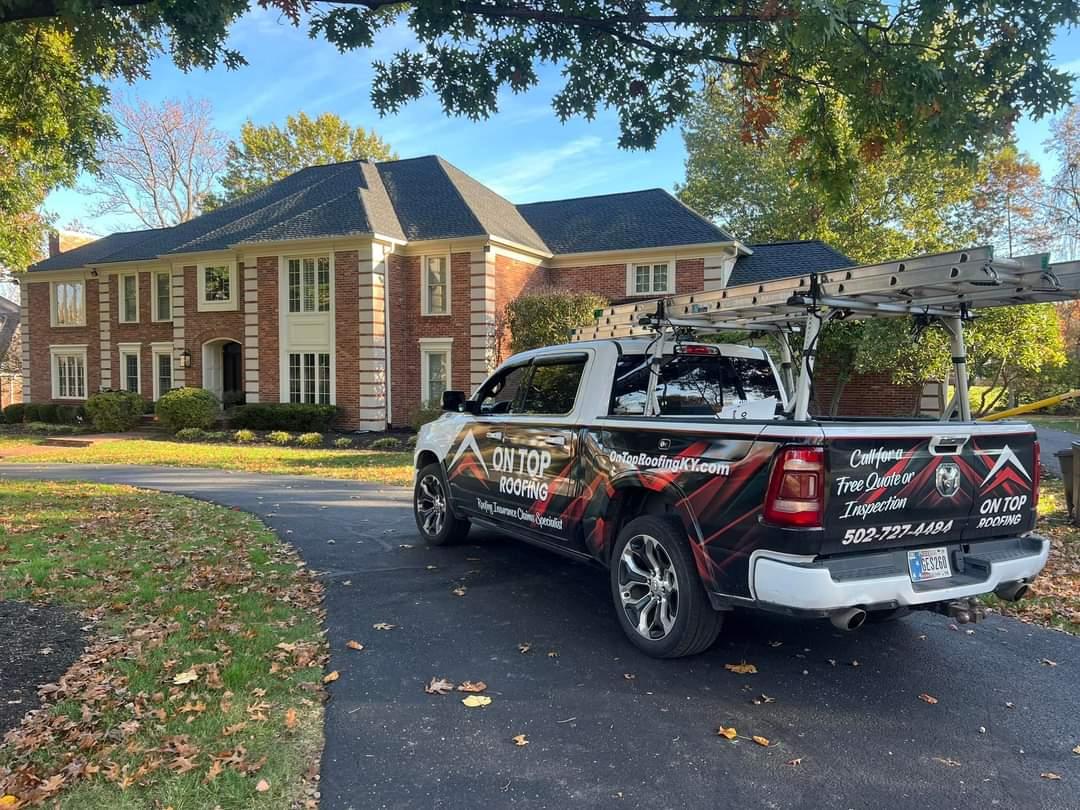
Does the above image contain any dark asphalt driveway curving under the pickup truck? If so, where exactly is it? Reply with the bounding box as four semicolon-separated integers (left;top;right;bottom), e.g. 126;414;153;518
0;465;1080;810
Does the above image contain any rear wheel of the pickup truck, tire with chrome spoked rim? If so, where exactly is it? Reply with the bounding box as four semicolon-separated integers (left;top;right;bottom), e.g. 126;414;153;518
610;515;724;658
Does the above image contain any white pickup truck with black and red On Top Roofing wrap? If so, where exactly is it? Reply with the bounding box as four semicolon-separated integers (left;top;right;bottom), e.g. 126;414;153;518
414;337;1049;658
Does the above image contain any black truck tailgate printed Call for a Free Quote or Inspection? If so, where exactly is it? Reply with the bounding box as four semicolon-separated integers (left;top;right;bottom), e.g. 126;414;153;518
822;423;1035;554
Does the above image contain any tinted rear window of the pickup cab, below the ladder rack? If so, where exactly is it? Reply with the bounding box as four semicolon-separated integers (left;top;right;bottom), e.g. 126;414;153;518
610;354;780;416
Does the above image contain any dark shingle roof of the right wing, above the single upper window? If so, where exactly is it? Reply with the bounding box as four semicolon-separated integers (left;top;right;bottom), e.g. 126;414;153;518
517;188;733;254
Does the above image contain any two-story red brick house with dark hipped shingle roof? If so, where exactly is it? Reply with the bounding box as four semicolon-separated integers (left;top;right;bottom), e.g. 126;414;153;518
23;157;851;430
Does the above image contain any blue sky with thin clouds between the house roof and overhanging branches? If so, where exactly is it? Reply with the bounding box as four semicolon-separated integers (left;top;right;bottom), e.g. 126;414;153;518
46;10;1080;233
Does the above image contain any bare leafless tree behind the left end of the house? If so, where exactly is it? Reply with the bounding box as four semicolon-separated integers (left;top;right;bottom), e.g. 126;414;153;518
87;99;226;228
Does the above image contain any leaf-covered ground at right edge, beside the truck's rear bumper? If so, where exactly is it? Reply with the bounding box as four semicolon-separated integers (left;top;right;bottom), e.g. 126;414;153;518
987;476;1080;635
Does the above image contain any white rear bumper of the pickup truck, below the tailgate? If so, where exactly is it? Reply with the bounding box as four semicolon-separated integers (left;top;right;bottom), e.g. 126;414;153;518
750;535;1050;612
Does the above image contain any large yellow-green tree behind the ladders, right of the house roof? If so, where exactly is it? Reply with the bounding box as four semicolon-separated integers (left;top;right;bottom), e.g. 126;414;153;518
677;83;975;262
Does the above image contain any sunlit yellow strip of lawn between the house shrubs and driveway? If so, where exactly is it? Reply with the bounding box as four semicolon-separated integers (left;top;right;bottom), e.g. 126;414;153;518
0;436;413;486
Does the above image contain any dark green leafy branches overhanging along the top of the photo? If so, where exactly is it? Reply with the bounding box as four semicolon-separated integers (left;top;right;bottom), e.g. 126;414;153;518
0;0;1078;196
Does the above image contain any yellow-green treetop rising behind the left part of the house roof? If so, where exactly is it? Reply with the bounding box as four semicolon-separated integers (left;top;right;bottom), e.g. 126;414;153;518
212;112;397;206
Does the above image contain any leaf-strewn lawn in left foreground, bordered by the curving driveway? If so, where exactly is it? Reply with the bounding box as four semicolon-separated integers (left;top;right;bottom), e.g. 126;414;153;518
0;482;325;810
